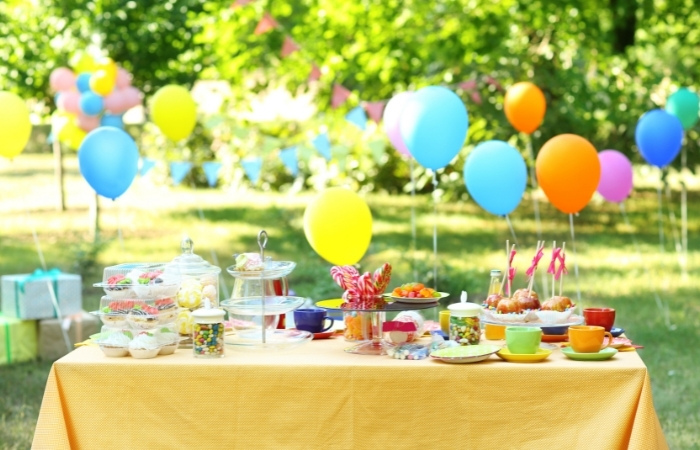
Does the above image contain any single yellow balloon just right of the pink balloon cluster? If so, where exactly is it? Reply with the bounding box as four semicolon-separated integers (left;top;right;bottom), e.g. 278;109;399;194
151;84;197;141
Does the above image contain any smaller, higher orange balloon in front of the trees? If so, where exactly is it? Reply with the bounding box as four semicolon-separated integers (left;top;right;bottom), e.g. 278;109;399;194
504;81;547;134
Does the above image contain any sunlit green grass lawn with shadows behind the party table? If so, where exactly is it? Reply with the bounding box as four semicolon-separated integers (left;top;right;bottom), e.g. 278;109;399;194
0;155;700;449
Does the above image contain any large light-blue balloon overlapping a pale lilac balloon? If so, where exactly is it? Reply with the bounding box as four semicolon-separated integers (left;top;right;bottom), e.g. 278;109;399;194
399;86;469;170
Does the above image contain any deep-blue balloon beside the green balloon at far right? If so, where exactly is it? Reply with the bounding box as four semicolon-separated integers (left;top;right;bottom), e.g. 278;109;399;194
634;109;683;168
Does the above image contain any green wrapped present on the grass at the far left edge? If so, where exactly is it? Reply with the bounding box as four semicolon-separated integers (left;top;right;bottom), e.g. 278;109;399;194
0;315;37;365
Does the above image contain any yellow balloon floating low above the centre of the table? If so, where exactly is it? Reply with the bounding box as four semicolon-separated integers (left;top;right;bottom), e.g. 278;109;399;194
304;188;372;266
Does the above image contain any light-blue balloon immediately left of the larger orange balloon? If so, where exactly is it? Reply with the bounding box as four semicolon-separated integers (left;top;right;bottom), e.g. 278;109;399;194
464;141;527;216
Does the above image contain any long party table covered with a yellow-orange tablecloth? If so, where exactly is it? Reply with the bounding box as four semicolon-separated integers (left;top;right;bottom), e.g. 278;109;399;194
33;337;667;450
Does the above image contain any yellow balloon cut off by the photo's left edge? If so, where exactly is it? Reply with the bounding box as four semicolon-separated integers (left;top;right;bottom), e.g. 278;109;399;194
0;91;32;159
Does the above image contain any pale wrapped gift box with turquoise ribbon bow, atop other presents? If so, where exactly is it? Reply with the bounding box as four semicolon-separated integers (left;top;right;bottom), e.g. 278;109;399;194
0;269;83;319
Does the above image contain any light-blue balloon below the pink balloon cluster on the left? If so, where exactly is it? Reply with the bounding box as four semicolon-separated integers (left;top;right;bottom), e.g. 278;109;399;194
78;127;139;200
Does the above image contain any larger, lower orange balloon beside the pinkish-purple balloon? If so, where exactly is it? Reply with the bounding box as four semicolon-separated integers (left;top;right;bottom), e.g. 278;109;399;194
535;134;600;214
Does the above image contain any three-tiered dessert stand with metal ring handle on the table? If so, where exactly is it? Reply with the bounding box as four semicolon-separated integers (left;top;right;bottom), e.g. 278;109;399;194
221;230;313;351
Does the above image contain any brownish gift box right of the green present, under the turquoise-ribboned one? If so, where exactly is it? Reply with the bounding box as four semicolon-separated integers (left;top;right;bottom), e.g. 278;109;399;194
38;311;101;361
